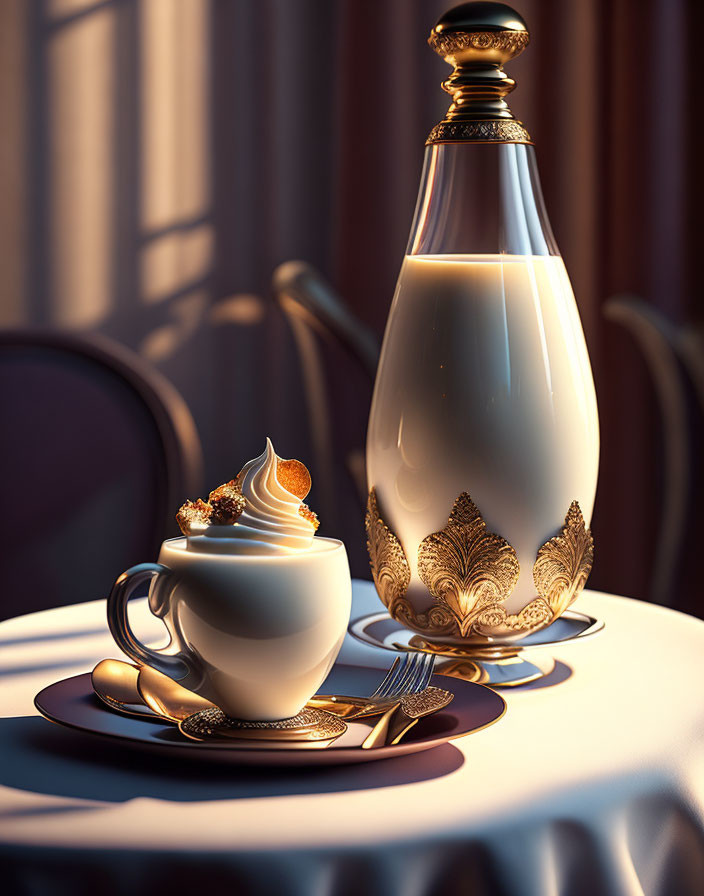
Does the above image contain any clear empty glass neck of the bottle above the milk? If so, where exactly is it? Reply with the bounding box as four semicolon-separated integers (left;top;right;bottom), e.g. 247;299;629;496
407;142;560;255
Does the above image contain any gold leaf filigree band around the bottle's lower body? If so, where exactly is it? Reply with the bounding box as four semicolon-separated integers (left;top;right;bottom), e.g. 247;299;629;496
366;489;594;639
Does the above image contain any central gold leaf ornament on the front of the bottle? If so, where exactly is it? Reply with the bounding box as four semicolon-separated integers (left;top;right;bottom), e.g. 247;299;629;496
418;492;520;638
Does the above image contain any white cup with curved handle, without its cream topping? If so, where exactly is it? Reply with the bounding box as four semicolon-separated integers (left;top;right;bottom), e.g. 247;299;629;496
107;538;352;721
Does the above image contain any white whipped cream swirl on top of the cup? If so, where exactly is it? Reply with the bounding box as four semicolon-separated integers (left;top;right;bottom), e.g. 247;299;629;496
188;439;315;555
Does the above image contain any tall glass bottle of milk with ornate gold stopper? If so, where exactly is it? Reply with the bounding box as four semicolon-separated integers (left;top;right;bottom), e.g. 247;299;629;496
367;3;599;641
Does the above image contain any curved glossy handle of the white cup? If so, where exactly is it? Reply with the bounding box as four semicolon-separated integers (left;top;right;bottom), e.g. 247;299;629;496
107;563;191;679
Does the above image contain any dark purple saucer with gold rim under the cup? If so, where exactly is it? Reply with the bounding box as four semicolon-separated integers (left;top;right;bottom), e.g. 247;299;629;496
34;665;506;765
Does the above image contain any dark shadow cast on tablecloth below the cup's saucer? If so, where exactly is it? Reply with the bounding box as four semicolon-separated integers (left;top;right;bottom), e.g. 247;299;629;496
0;716;464;802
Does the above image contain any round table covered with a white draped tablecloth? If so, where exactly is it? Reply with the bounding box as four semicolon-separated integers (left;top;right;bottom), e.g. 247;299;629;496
0;582;704;896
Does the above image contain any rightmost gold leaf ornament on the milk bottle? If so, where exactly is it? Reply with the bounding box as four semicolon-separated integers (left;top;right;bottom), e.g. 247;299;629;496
533;501;594;619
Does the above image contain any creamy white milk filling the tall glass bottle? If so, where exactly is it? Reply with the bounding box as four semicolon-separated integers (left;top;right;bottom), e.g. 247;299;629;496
367;255;599;612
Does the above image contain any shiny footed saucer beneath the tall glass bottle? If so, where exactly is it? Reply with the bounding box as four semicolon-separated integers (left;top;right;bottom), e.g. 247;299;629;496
349;610;604;688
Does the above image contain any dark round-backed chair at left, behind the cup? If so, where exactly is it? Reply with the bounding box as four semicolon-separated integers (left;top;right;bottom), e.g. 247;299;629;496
0;331;202;618
